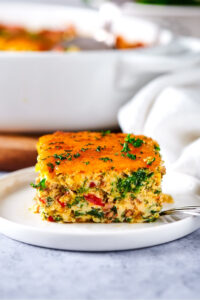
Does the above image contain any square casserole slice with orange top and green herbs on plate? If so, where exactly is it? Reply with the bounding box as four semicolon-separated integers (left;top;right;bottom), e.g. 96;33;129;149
32;131;165;223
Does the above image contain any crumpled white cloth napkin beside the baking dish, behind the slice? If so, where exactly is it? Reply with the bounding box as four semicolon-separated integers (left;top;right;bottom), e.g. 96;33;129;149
118;68;200;193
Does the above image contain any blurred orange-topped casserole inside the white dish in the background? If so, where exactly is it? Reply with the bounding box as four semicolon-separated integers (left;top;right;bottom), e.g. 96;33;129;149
0;24;147;52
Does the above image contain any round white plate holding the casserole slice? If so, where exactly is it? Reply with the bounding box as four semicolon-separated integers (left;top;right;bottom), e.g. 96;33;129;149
0;168;200;251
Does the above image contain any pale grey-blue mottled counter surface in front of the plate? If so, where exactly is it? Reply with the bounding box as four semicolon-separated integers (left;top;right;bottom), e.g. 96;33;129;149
0;230;200;300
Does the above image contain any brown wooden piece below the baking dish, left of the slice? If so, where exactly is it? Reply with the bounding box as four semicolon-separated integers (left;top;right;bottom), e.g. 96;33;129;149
0;134;37;171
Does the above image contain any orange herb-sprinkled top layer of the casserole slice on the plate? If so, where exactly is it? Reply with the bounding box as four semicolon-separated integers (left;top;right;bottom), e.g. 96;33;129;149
36;132;161;178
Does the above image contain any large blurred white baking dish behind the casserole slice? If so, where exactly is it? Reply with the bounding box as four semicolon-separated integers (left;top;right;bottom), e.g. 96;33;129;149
0;3;198;132
